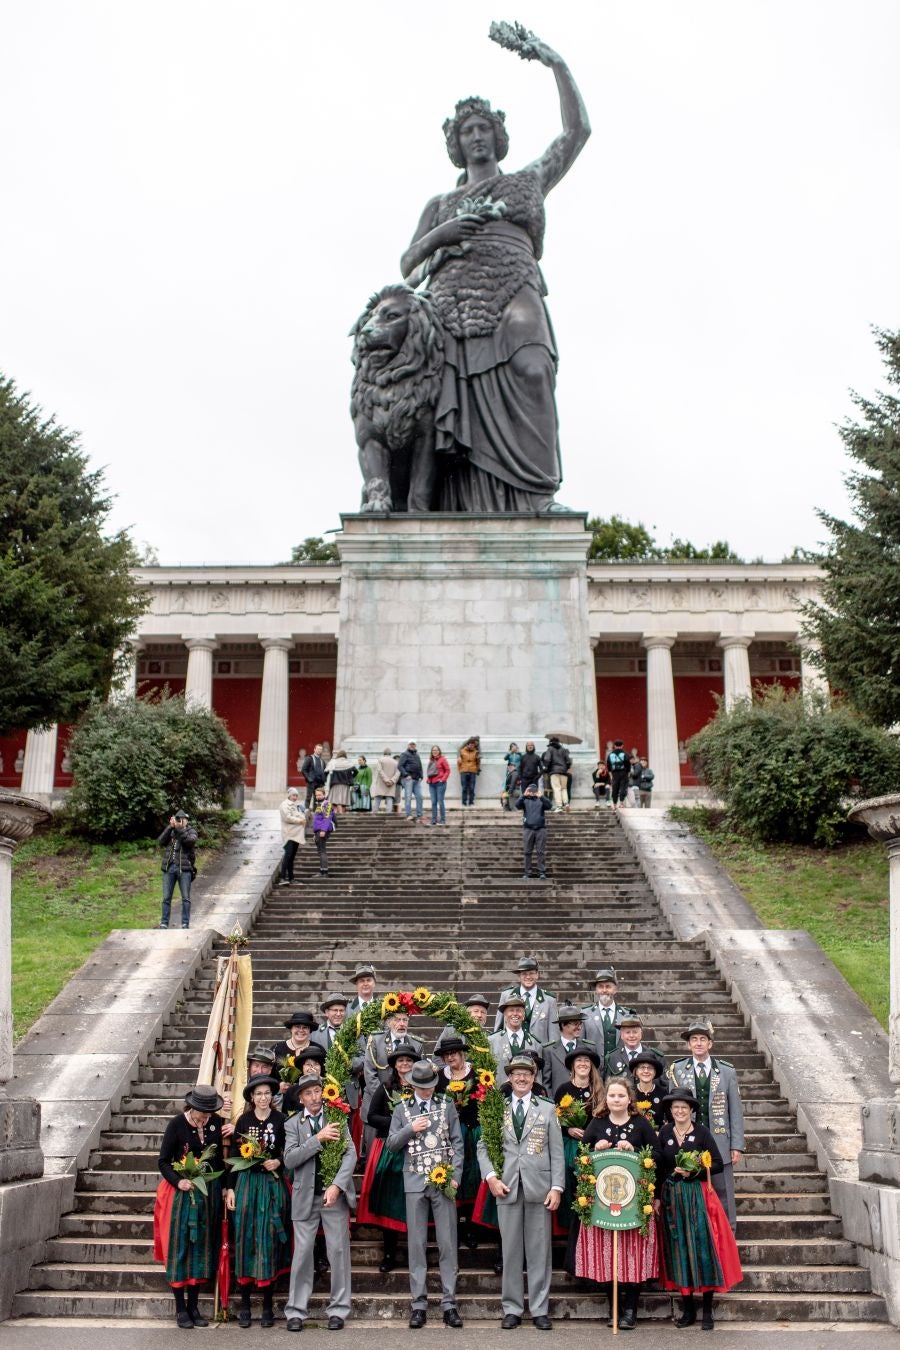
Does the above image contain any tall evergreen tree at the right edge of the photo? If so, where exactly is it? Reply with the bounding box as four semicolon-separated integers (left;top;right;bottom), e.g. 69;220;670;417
806;329;900;729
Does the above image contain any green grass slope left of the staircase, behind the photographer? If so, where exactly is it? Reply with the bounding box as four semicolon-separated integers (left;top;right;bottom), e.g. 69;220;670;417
12;811;239;1041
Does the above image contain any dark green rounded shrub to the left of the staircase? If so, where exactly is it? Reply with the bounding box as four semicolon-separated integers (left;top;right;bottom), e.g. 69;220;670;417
65;697;244;840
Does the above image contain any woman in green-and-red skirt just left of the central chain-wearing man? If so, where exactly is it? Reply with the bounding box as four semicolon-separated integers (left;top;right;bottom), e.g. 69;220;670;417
356;1041;420;1274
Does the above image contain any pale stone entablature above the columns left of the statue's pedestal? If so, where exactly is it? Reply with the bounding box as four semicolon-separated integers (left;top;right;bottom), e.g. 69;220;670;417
134;563;340;648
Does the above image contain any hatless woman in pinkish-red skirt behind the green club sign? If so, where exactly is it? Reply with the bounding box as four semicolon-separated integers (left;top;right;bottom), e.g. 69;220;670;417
569;1077;658;1331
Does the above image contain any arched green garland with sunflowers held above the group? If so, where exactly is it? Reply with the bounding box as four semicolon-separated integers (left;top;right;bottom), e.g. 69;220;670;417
320;986;506;1187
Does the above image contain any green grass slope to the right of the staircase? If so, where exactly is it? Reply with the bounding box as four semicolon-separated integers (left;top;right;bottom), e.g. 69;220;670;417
671;806;889;1027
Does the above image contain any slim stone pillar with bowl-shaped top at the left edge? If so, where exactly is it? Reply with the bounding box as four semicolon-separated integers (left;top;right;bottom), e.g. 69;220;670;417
0;791;50;1184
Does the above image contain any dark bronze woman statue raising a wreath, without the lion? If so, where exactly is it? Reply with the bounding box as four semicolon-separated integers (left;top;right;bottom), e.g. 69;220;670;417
401;30;591;514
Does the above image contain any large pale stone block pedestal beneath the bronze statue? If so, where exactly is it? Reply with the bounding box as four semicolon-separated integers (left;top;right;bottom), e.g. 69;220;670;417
335;513;596;803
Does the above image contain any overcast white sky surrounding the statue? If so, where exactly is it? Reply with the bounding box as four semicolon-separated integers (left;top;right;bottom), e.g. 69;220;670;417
0;0;900;563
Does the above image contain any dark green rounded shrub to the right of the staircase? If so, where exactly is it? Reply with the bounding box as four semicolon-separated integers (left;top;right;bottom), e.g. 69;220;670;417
688;684;900;846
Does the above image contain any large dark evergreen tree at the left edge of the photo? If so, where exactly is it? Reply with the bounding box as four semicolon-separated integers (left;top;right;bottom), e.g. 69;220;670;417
0;375;146;734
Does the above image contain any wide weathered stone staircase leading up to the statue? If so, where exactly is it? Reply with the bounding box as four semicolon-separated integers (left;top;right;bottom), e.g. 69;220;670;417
13;810;887;1323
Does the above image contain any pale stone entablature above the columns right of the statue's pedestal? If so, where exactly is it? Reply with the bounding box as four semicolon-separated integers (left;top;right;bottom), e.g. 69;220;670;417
587;563;823;643
